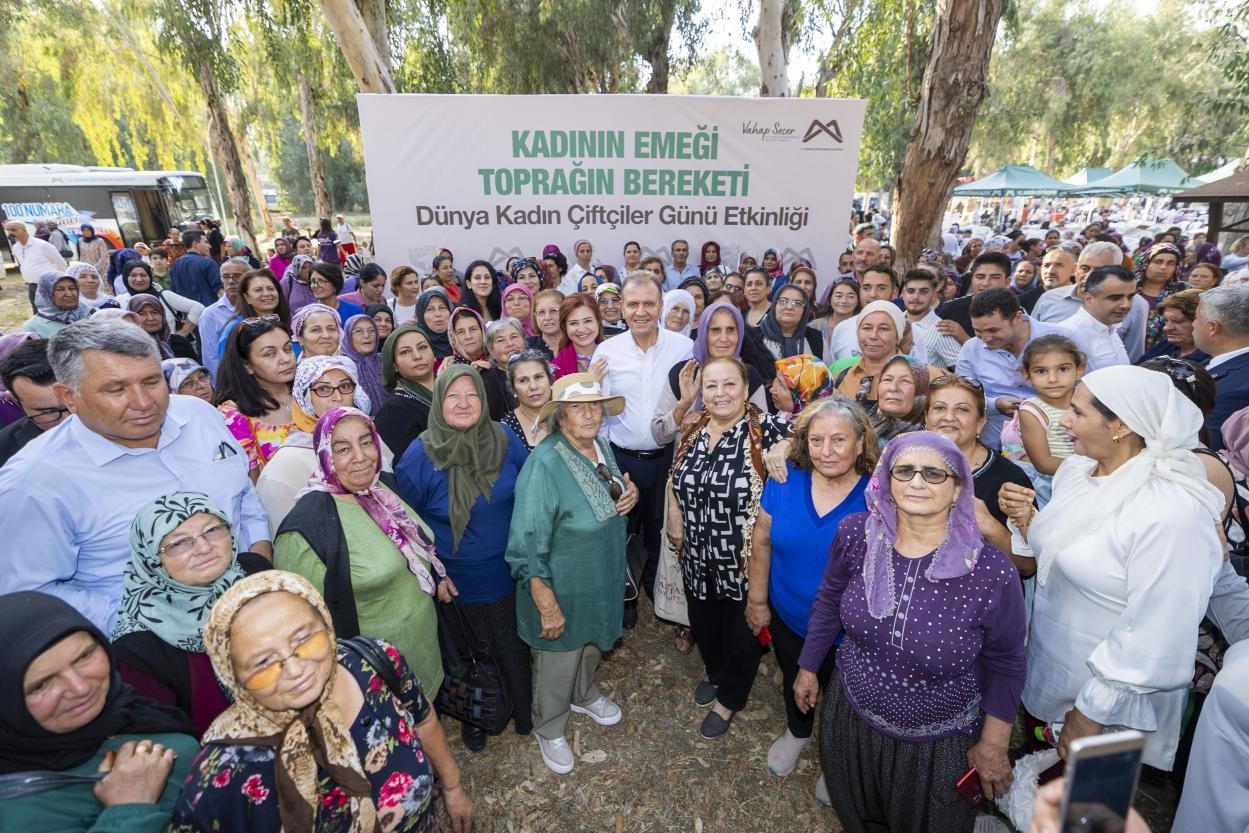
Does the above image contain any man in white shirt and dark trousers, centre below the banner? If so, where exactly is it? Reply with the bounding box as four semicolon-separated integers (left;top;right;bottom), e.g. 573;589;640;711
591;271;693;627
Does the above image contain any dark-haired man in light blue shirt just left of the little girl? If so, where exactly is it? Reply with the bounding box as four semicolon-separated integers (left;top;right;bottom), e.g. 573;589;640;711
954;287;1084;451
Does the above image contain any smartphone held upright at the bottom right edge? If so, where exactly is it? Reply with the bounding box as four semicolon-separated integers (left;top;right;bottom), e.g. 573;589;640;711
1060;729;1145;833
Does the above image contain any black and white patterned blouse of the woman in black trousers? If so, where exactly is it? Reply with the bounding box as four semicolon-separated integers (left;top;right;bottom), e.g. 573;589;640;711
672;415;791;601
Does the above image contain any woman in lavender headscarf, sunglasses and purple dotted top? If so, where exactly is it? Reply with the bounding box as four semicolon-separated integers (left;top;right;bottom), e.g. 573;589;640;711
793;431;1025;833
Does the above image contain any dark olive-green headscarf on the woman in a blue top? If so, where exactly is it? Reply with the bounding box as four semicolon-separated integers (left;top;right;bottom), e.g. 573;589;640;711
422;362;507;550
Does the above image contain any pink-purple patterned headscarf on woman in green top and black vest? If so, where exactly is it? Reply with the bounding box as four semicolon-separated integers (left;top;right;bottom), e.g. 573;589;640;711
309;408;447;596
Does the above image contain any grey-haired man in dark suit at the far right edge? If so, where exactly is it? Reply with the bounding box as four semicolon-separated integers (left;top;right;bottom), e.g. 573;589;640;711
1193;283;1249;451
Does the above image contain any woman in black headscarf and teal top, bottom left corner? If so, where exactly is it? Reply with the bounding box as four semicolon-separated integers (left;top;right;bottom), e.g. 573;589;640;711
0;592;199;833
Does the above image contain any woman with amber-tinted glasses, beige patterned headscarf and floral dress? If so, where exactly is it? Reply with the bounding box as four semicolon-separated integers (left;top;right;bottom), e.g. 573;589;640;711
170;569;472;833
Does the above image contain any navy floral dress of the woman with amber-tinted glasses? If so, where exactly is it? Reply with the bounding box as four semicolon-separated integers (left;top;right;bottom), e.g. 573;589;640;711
170;639;441;833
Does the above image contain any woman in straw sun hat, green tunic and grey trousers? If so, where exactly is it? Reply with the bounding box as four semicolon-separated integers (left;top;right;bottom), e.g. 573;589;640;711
507;373;638;774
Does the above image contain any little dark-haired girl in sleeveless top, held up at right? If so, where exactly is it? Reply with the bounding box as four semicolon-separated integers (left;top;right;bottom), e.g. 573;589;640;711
1018;336;1084;506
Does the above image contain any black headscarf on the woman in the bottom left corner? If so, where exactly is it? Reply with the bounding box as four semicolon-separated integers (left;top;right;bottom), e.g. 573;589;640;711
0;591;196;774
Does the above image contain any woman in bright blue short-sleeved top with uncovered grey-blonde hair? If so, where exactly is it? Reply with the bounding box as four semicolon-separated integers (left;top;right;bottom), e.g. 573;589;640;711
746;395;879;803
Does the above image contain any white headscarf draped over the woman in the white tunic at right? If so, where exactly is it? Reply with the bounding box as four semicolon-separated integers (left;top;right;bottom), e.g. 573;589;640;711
1028;365;1223;584
